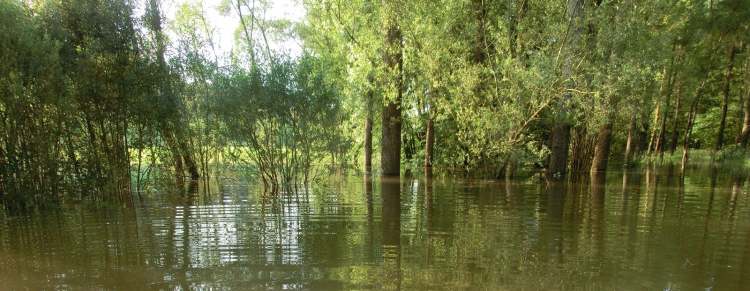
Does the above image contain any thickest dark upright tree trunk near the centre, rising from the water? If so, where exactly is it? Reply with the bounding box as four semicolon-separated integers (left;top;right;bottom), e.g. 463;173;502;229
380;13;403;176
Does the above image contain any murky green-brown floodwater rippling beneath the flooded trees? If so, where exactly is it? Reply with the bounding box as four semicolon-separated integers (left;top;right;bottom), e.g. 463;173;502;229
0;169;750;290
